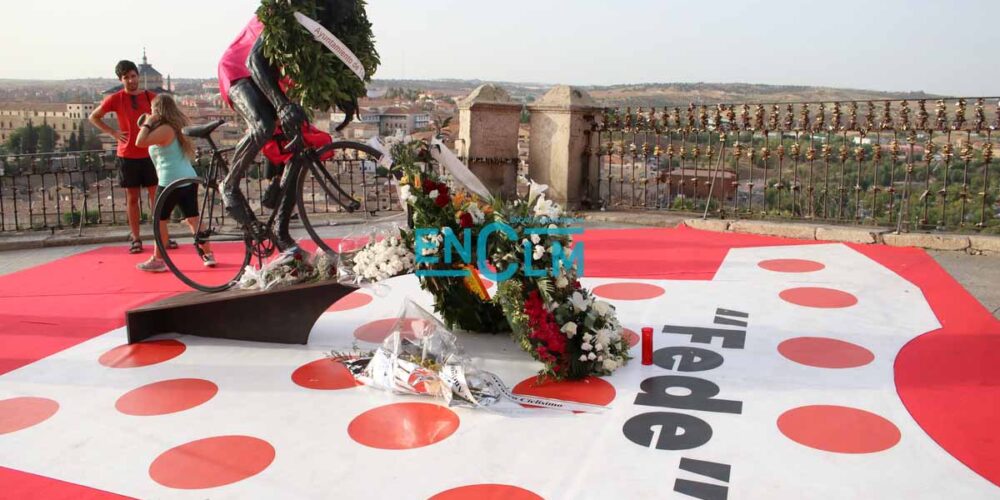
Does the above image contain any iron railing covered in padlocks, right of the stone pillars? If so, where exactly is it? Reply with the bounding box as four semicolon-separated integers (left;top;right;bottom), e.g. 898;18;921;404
586;97;1000;232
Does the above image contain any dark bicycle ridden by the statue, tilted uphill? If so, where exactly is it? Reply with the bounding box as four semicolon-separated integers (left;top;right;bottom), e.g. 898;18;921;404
153;120;382;292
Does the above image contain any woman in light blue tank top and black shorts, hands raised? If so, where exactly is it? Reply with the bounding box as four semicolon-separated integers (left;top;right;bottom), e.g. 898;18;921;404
135;94;215;273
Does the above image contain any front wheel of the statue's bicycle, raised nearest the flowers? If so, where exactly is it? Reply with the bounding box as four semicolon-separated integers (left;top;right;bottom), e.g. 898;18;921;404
296;142;384;254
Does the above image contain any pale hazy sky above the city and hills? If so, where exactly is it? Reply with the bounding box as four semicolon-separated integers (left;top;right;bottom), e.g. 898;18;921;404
0;0;1000;96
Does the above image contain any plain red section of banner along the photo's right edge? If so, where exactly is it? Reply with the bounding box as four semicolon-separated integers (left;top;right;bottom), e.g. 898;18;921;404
851;245;1000;486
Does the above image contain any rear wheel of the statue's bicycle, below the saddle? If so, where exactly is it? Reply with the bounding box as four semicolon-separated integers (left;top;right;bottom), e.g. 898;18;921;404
153;177;251;292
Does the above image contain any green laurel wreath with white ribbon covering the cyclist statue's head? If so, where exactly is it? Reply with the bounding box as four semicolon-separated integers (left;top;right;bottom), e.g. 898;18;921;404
257;0;380;111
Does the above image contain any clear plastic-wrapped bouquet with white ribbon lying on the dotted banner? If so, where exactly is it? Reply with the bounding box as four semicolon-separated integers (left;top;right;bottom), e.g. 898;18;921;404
330;300;607;416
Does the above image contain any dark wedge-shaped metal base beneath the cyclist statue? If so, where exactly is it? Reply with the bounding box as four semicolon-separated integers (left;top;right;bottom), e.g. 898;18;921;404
125;281;357;344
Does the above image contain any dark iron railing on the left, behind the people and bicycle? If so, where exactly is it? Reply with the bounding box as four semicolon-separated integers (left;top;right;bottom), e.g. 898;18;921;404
0;146;400;232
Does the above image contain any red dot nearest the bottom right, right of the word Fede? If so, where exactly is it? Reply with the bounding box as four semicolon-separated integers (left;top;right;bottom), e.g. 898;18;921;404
778;405;900;453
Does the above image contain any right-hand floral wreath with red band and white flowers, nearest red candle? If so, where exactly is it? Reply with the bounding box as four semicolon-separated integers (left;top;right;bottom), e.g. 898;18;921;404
492;182;630;380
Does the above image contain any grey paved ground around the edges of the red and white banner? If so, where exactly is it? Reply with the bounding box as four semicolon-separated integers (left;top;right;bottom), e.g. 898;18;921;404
0;218;1000;318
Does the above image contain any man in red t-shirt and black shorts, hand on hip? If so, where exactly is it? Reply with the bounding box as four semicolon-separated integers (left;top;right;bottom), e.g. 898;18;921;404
90;61;157;253
